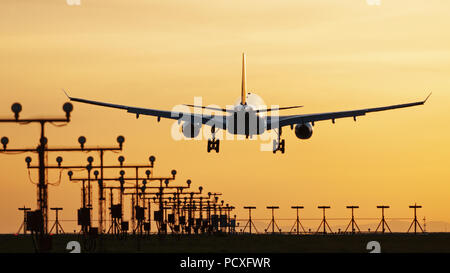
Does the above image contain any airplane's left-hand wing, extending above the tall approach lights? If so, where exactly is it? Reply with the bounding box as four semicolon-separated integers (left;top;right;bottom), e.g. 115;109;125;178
63;90;226;130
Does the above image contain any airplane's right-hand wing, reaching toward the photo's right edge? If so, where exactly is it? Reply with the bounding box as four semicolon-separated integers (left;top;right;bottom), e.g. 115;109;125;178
269;93;431;128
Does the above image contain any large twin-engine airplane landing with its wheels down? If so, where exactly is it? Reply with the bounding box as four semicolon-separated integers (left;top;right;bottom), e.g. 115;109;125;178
63;53;431;154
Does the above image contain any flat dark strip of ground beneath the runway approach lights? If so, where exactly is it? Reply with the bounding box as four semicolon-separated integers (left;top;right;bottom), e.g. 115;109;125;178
0;233;450;253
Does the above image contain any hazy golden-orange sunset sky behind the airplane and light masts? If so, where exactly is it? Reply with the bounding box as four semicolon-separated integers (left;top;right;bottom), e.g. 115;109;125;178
0;0;450;233
